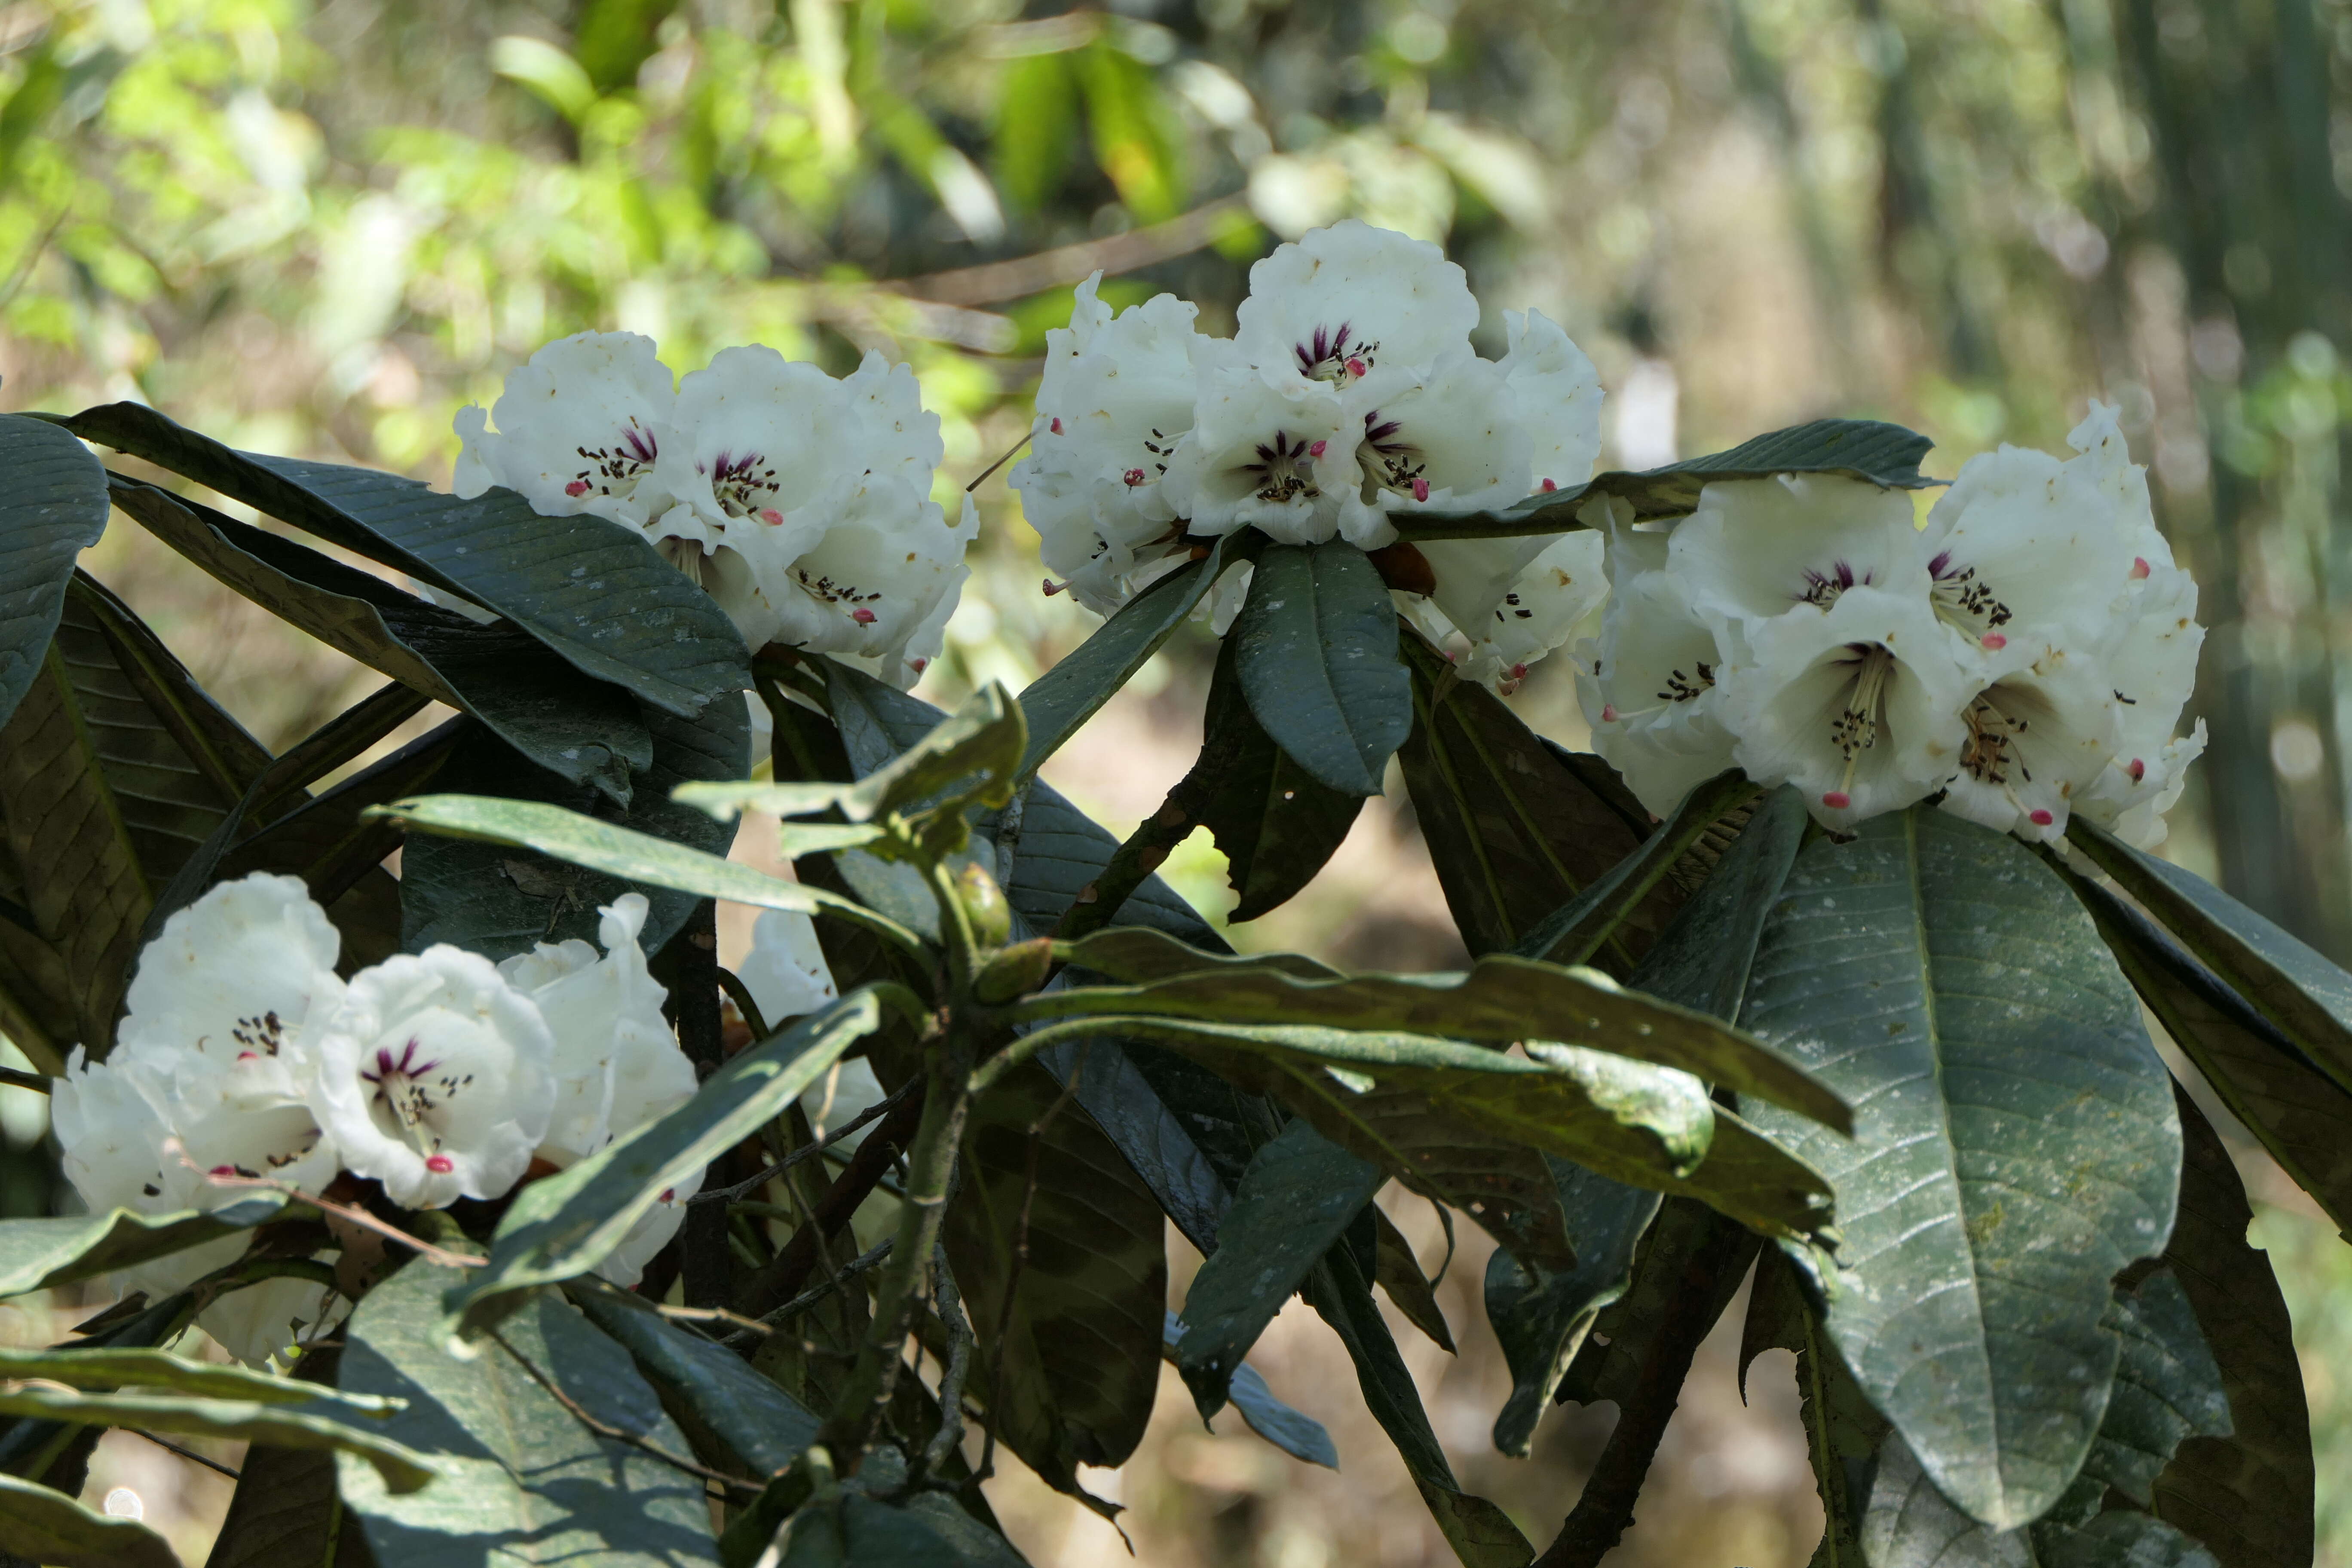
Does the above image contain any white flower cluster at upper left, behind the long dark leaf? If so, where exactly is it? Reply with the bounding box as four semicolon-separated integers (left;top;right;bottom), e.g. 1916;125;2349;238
456;331;978;689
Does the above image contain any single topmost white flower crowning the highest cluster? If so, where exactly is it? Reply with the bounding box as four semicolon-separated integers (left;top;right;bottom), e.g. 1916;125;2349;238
1235;219;1479;386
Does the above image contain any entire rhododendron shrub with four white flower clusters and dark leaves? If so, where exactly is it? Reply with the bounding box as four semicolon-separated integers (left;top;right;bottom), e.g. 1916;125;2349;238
0;224;2314;1568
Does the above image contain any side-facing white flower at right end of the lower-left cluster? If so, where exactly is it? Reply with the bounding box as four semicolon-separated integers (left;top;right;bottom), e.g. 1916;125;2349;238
499;893;694;1166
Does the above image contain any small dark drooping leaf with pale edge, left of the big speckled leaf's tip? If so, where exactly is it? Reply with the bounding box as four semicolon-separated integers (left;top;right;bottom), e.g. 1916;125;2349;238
1486;1161;1658;1458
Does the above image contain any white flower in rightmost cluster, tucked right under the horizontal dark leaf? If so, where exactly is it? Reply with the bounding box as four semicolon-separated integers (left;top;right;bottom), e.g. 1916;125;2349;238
1668;475;1929;661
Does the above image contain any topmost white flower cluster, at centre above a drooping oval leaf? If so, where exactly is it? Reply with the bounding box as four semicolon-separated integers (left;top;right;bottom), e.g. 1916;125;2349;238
1011;221;1606;682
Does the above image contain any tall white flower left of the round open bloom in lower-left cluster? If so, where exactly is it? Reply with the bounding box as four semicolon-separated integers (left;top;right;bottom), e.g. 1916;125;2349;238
113;872;343;1206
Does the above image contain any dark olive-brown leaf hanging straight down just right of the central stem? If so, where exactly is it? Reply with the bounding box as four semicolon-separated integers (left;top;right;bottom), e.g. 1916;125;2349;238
943;1063;1167;1500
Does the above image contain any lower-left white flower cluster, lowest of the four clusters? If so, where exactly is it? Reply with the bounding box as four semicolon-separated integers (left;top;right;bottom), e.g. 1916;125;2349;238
52;875;696;1361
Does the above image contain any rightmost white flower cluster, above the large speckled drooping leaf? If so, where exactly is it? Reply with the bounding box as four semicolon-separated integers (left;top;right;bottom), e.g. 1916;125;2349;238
1580;404;2204;846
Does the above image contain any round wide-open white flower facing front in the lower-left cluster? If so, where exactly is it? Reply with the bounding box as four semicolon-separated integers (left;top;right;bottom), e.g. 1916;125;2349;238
310;945;555;1208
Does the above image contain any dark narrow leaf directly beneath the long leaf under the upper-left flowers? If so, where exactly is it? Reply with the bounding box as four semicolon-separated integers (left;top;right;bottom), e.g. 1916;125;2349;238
113;480;654;806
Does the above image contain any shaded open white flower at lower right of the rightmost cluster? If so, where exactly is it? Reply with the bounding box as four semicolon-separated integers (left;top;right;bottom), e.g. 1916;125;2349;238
1943;642;2119;842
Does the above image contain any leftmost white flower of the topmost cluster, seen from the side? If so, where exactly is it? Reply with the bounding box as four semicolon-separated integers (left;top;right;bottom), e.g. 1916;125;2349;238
1009;273;1200;616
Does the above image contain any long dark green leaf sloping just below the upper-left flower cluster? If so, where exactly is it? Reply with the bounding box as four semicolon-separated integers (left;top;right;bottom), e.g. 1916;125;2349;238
68;402;750;717
